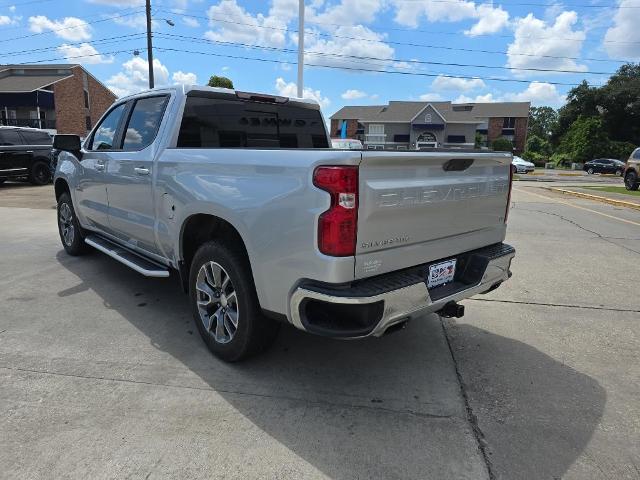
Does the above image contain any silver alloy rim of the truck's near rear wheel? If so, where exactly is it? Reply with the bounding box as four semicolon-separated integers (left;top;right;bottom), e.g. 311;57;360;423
196;262;239;344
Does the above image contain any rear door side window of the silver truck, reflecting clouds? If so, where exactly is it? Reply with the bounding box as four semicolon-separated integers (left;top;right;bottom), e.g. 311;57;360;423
122;95;169;150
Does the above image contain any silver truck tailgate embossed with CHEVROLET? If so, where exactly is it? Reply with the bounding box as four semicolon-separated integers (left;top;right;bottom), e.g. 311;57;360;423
355;151;511;278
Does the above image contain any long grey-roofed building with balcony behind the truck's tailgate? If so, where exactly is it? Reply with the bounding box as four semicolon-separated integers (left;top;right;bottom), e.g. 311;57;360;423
331;101;530;154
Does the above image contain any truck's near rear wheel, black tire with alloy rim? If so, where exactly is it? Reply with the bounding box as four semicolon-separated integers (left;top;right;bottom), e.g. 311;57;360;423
189;241;280;362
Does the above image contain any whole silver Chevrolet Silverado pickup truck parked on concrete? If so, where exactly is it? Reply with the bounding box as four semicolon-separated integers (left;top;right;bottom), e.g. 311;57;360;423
54;87;515;361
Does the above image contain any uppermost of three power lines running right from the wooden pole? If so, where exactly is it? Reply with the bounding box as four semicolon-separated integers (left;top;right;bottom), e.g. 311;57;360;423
161;8;627;63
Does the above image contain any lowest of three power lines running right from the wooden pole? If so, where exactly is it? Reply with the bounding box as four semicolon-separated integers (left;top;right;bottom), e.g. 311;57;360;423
154;47;599;87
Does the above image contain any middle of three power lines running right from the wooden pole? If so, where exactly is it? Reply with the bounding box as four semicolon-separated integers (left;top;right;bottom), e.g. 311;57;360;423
156;33;615;75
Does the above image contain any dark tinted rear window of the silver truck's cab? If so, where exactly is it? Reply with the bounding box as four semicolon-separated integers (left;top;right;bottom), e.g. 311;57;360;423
177;97;329;148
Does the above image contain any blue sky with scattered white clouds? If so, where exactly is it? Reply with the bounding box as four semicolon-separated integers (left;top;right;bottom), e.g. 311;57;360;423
0;0;640;115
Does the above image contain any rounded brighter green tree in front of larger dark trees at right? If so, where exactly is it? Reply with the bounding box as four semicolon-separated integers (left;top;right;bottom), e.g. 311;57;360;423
558;116;611;163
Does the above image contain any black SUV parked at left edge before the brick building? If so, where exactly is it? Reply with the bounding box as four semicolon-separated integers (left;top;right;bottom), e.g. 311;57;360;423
0;127;52;185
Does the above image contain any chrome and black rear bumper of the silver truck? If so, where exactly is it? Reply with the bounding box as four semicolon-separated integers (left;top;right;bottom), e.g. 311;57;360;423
290;243;515;338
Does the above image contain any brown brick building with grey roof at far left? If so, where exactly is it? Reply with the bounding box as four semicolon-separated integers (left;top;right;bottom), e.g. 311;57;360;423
0;64;116;136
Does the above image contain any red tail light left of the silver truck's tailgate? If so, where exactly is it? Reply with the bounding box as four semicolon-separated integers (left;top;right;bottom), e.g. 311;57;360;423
313;166;358;257
